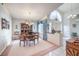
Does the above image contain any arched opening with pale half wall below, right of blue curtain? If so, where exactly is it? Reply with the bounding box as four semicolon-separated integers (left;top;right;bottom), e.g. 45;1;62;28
48;10;62;45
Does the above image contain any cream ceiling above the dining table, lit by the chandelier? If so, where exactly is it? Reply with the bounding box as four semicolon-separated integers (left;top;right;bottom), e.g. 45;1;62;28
4;3;61;21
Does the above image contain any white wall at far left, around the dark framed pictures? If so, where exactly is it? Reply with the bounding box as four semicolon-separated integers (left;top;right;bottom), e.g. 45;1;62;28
0;5;12;54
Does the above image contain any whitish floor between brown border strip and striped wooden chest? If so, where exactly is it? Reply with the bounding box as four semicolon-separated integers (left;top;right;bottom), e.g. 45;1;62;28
45;39;66;56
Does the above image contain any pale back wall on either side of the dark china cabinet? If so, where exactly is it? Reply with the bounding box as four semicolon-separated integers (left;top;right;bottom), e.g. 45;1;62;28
12;19;37;34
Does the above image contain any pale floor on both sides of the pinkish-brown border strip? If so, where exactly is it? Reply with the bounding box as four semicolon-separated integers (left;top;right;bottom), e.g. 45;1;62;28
2;34;66;56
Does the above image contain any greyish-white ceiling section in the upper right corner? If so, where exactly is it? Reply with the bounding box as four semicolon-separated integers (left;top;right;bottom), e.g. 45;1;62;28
58;3;79;13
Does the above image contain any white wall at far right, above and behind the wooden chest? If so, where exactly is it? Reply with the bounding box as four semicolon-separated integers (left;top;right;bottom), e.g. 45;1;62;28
63;8;79;40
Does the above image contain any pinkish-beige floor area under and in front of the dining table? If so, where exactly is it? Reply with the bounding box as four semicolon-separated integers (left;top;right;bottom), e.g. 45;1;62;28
8;40;56;56
